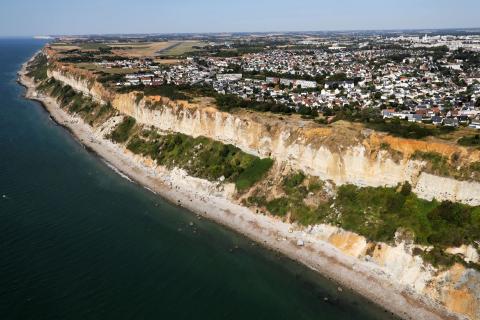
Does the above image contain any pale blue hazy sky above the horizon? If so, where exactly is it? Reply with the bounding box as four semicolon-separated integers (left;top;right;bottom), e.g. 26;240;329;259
0;0;480;36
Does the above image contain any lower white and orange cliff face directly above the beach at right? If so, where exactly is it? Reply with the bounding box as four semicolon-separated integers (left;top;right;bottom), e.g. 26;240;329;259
310;225;480;319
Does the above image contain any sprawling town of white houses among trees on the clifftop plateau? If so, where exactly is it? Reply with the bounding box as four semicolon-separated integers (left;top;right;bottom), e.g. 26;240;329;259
51;34;480;129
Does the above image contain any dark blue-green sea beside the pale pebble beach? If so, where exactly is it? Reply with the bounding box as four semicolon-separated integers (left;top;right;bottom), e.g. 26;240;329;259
0;39;398;319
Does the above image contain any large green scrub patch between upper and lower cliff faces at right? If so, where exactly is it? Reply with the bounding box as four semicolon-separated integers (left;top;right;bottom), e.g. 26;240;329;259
246;172;480;252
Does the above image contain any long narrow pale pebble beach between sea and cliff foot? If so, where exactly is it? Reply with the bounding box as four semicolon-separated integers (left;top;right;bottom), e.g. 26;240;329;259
19;58;459;320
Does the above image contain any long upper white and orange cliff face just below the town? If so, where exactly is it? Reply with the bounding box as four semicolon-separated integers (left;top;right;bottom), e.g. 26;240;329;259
49;71;480;205
